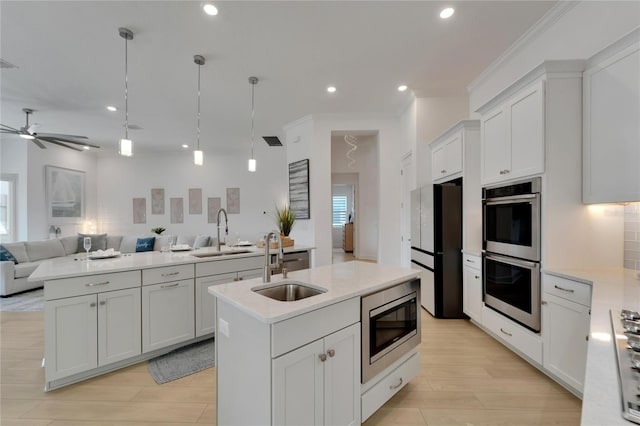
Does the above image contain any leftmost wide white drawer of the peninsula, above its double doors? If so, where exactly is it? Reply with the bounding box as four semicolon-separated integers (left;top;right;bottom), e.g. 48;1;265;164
44;271;140;300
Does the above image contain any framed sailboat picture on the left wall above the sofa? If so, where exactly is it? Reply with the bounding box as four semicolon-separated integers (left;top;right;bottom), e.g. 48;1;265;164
44;166;85;223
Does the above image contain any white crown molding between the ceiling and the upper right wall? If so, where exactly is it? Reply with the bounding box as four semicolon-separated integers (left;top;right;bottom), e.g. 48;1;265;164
467;0;581;93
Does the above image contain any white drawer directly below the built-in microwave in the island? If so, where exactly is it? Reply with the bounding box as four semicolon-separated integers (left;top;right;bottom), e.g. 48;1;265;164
362;353;420;422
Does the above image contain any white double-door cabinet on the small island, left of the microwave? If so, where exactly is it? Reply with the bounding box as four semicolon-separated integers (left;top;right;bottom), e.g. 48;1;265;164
272;324;360;425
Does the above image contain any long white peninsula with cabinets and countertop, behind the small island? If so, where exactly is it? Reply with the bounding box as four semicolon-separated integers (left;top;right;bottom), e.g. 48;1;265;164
29;246;313;391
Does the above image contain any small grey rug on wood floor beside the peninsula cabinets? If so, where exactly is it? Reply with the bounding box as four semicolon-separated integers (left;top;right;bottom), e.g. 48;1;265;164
148;338;215;385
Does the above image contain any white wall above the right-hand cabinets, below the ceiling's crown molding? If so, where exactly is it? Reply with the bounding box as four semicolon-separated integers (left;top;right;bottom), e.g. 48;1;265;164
469;1;640;113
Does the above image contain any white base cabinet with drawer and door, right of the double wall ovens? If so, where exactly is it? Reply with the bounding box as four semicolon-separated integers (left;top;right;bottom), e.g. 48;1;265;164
542;274;591;394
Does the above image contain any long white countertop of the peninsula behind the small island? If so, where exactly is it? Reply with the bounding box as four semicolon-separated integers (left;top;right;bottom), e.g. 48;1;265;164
29;245;313;281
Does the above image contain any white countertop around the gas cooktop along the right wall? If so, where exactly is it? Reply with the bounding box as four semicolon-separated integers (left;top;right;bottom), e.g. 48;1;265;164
544;268;640;426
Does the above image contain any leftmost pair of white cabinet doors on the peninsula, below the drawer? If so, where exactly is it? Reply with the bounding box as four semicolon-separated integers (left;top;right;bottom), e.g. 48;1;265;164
45;287;141;382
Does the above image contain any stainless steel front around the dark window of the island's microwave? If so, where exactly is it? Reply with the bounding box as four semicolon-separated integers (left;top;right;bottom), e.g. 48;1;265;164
361;279;422;383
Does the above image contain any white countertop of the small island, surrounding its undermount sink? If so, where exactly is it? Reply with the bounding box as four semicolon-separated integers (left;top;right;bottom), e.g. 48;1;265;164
209;261;420;324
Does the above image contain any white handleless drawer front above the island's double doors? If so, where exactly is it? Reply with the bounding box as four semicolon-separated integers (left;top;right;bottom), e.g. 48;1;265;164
271;297;360;358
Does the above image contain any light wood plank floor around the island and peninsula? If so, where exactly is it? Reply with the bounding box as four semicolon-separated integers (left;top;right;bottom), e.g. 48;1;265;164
0;300;581;426
